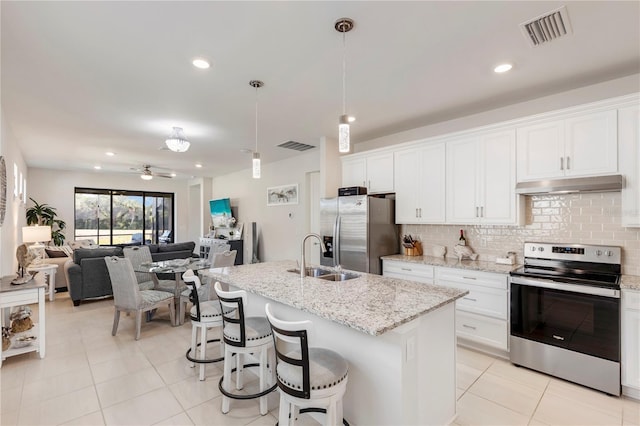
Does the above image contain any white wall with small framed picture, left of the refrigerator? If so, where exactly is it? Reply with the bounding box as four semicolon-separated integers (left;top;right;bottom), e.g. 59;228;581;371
211;149;320;263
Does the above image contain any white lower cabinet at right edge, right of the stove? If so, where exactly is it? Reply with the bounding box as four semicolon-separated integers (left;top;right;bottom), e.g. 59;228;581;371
621;290;640;399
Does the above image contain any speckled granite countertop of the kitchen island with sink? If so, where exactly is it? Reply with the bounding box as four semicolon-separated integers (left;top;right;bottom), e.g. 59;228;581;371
204;261;468;336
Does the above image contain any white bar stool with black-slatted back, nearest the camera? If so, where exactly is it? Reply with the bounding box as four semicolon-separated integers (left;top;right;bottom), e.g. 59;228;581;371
264;303;349;426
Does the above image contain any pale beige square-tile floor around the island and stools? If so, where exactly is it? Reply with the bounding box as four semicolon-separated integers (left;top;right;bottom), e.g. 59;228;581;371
0;293;640;426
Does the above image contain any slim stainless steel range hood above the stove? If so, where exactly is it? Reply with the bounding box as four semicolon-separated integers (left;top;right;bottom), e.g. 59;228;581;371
516;175;624;195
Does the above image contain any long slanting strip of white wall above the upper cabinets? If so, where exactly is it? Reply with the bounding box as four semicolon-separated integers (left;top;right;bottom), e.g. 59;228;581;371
354;74;640;152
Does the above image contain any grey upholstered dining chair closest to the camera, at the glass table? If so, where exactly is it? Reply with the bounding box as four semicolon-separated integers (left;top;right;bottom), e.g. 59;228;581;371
104;256;175;340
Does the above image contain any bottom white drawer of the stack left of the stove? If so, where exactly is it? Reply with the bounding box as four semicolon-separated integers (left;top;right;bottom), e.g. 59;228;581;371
456;311;509;351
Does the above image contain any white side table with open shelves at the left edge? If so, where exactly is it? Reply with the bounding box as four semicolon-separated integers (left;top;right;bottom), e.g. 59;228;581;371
0;276;45;367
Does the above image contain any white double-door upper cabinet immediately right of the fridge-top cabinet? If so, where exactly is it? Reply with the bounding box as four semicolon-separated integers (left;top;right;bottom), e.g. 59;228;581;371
394;142;445;224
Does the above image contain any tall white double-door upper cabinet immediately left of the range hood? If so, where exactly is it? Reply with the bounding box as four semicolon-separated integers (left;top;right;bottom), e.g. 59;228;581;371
446;130;520;225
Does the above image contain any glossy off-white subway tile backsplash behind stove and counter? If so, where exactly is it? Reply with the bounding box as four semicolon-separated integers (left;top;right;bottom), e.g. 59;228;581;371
401;192;640;275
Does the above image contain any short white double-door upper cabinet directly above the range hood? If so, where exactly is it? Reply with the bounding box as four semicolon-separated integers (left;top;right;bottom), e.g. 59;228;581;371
517;110;618;182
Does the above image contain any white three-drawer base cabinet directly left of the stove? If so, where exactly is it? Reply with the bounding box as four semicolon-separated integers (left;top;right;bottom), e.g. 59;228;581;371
435;267;509;354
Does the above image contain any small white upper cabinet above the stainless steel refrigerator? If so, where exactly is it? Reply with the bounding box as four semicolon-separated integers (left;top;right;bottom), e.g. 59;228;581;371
342;152;394;194
